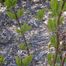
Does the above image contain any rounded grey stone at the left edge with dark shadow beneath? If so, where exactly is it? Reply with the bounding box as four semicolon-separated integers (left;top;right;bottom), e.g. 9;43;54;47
0;29;13;44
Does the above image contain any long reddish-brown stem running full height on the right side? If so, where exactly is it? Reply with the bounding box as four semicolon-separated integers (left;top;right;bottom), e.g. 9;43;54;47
53;1;65;66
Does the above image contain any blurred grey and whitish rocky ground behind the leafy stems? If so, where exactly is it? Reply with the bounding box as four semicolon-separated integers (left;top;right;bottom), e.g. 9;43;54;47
0;0;66;66
